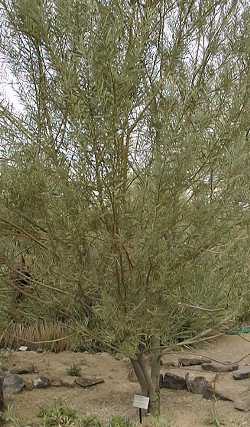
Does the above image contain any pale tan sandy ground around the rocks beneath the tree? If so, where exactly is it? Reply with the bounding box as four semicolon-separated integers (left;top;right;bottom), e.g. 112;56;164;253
2;336;250;427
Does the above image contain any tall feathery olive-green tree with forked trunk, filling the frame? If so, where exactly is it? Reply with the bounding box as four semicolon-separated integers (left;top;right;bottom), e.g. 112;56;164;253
0;0;249;413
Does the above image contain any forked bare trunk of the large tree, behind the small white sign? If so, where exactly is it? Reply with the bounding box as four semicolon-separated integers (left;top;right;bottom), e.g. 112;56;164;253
131;337;160;416
